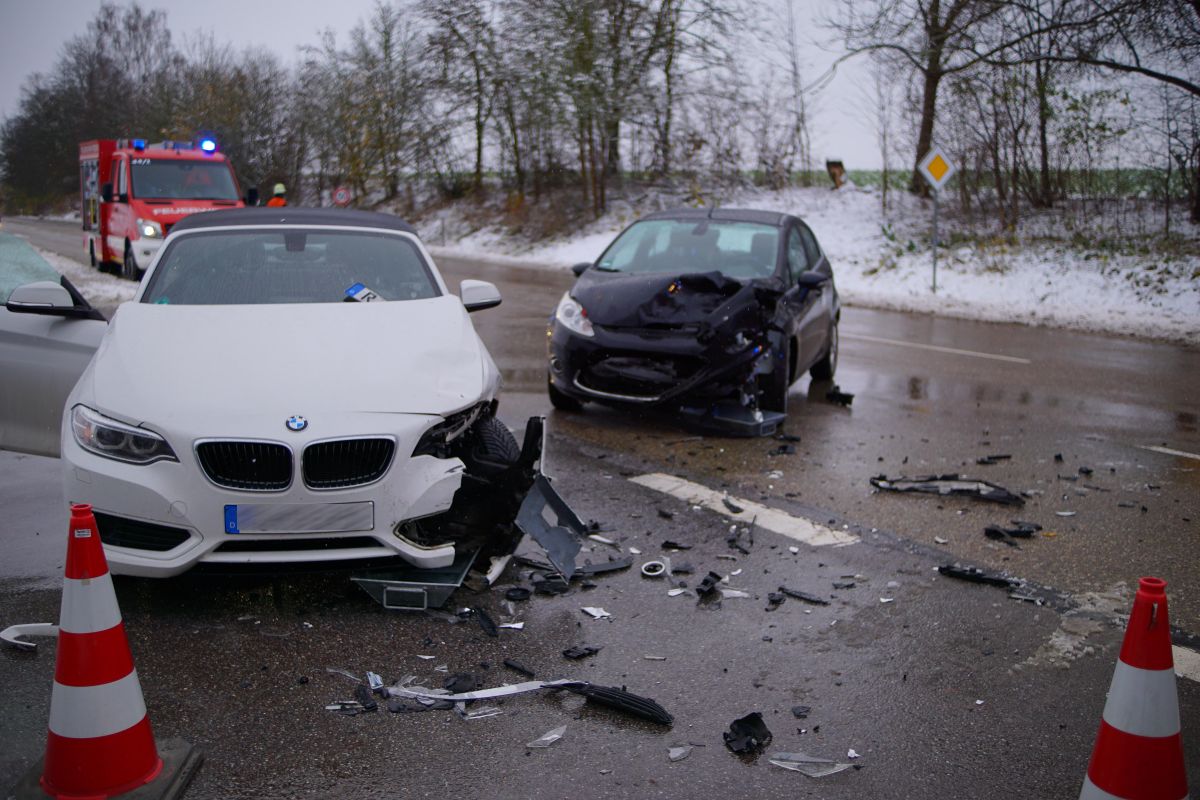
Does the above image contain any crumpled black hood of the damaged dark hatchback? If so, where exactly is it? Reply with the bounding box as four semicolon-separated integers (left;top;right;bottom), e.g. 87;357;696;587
571;270;779;327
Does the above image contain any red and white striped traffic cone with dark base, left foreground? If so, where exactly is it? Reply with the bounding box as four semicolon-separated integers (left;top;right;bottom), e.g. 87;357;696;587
16;505;200;800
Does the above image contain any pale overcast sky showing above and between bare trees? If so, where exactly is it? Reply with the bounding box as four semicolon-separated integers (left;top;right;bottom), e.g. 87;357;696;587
0;0;894;169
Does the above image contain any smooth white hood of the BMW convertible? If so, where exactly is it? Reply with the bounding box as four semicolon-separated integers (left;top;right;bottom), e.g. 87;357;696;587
85;295;497;425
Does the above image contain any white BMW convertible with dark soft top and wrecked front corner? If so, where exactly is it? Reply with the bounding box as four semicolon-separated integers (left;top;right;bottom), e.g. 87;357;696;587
10;209;530;577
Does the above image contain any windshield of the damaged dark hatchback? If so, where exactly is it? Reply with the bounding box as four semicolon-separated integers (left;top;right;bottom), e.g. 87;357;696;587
596;219;779;278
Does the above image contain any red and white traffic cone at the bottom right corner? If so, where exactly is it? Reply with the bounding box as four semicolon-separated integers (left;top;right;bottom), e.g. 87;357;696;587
1079;578;1188;800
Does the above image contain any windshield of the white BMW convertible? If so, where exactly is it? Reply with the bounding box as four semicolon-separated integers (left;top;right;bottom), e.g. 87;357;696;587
142;228;442;306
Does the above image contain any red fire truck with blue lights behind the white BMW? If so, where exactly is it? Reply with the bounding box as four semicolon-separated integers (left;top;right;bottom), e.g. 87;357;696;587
79;137;244;281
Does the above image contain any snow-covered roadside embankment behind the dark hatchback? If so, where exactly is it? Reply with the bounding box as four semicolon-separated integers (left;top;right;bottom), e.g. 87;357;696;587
422;186;1200;344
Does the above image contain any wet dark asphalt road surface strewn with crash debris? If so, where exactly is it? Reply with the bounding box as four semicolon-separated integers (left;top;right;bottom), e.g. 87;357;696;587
0;215;1200;798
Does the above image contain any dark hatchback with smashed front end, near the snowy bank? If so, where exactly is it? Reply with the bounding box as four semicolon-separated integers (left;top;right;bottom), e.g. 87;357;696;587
548;209;841;435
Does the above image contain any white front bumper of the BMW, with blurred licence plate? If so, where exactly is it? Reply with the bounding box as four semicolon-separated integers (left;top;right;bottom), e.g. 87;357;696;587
62;414;464;577
